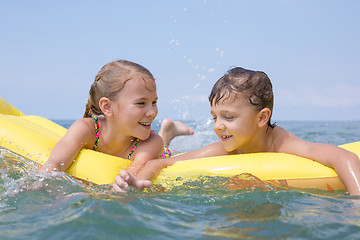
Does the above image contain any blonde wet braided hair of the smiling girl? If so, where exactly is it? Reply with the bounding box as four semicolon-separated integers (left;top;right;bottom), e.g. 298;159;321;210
84;60;155;118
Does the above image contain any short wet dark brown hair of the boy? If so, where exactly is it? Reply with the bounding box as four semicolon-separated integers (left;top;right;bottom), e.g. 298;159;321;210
209;67;275;128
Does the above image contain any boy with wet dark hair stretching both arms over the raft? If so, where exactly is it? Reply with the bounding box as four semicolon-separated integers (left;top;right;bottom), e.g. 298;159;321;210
115;67;360;195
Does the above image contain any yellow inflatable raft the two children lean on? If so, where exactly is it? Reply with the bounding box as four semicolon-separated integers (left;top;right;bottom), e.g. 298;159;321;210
0;98;360;190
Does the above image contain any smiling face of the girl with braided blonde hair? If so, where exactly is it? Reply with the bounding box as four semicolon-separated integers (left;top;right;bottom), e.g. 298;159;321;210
113;78;158;140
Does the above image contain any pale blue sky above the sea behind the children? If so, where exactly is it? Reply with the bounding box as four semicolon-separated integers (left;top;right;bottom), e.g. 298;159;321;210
0;0;360;121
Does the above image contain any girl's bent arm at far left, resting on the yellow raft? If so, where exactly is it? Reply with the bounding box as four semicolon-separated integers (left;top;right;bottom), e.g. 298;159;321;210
40;118;95;172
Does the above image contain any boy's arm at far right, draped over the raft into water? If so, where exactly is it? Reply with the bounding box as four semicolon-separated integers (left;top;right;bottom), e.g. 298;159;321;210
280;136;360;195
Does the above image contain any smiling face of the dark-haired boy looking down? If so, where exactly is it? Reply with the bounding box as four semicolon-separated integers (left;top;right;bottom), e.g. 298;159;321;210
211;94;259;153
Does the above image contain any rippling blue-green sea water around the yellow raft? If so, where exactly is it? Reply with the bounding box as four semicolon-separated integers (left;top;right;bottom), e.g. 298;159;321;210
0;120;360;240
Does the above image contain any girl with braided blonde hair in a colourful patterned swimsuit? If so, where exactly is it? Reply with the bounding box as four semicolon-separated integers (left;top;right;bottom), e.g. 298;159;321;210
41;60;193;188
